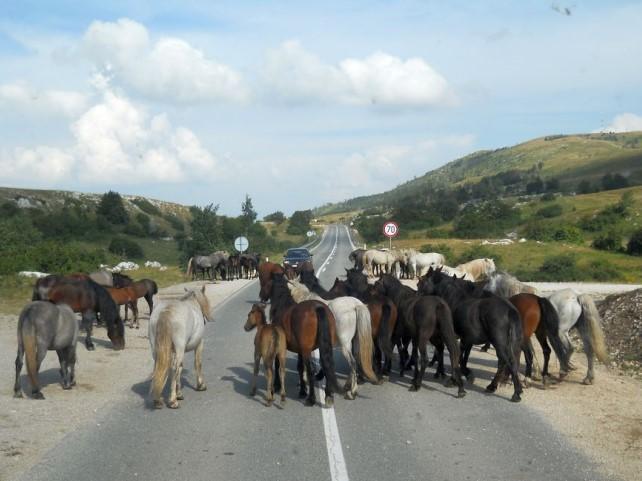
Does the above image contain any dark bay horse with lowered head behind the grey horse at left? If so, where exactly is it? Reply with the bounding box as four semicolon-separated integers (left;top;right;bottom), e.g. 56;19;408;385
44;278;125;351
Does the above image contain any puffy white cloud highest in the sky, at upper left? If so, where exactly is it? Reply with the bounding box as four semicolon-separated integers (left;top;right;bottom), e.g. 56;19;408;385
81;18;248;103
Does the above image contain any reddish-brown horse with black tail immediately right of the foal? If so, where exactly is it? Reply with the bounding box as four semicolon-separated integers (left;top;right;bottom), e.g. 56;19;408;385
262;270;341;406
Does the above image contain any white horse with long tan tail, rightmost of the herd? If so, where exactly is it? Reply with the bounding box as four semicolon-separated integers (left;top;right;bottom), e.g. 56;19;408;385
547;289;609;384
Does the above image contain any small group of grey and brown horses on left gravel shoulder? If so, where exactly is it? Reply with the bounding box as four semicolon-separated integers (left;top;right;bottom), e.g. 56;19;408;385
14;271;158;399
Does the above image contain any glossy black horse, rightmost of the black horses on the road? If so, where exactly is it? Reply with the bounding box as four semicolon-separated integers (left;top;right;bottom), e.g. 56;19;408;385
418;268;522;402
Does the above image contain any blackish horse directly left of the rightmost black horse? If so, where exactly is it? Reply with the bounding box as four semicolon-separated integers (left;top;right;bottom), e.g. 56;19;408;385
375;274;466;397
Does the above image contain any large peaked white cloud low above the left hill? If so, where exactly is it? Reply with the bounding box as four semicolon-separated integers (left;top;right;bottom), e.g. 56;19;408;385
0;90;223;186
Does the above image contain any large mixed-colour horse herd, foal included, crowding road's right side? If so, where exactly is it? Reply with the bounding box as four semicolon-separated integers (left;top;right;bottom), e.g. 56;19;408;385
245;249;608;405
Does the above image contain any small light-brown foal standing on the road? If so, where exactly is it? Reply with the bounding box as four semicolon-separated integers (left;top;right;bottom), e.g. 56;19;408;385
243;304;287;406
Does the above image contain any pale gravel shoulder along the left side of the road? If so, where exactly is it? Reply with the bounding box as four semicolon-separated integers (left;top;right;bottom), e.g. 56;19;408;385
0;279;252;480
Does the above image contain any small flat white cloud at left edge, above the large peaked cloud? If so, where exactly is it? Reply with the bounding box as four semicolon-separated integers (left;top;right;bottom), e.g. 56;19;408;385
0;84;87;117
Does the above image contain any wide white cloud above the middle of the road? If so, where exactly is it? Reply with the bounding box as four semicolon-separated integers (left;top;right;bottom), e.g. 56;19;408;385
262;41;457;107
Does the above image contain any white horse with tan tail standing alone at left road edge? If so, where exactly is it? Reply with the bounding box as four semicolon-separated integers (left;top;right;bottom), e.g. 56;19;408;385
149;286;214;409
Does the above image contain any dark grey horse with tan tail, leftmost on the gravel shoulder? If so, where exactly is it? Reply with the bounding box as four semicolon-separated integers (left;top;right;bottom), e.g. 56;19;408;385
13;301;78;399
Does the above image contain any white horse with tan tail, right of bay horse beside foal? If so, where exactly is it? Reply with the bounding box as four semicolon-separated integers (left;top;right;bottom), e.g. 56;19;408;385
288;280;379;399
